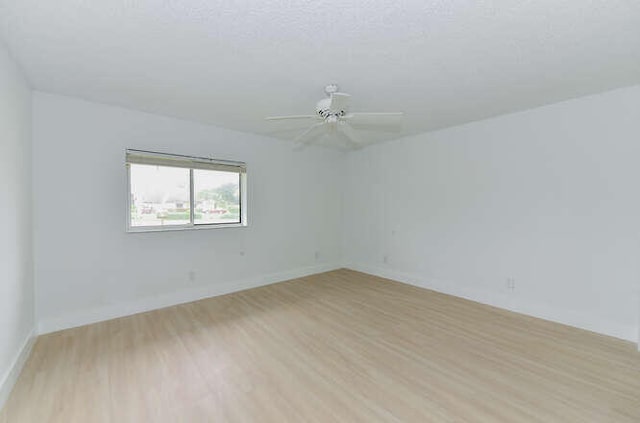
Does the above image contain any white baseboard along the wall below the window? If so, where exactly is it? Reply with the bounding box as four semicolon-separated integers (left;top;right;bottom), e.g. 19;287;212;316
38;264;342;334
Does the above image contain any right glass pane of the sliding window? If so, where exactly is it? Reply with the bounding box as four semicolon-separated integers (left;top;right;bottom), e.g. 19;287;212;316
193;169;240;224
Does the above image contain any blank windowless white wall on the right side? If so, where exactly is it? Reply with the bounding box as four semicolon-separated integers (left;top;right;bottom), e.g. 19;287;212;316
344;86;640;340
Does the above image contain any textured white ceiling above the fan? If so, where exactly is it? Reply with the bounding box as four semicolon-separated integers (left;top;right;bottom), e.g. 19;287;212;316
0;0;640;145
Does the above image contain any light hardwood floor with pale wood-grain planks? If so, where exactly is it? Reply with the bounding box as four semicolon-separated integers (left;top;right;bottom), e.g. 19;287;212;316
0;270;640;423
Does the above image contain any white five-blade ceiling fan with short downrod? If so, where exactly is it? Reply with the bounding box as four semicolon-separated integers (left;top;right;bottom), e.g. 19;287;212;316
266;84;402;149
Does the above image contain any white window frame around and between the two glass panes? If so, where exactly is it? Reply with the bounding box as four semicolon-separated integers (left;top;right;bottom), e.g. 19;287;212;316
125;149;248;233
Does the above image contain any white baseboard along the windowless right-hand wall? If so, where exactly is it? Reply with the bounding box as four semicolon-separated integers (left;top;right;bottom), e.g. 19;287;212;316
343;263;640;349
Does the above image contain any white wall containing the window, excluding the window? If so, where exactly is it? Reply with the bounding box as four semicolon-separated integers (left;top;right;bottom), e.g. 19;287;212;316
34;93;344;332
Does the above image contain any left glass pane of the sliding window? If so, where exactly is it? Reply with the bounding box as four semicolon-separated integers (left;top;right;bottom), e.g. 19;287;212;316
129;164;191;226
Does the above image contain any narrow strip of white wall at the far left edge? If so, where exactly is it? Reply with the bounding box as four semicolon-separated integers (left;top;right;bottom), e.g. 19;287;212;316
0;45;34;407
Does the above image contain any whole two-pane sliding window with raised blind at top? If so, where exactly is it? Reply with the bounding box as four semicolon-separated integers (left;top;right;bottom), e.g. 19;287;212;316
126;150;247;232
